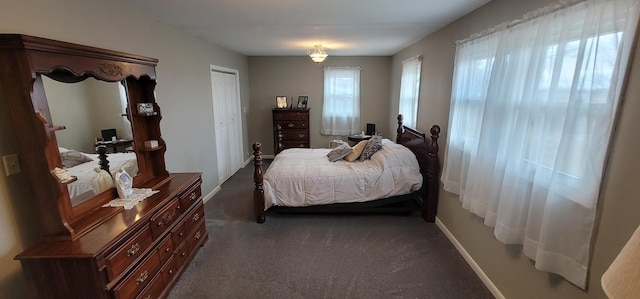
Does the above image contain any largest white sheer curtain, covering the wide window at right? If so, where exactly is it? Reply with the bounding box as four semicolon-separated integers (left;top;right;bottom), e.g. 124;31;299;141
442;0;638;288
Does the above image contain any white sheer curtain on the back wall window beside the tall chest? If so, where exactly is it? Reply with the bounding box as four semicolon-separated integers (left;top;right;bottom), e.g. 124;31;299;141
320;67;360;135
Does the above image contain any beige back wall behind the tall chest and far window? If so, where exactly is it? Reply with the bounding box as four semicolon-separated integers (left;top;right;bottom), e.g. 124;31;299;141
248;56;395;155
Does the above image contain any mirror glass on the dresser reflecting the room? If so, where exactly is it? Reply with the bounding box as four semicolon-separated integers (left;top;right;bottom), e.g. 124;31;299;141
42;74;138;206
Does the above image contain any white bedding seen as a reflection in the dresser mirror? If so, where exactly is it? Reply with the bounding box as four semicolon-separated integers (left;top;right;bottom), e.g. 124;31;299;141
66;153;138;202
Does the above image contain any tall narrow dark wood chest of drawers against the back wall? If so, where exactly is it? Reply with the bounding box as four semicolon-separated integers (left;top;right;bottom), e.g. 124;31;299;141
273;109;310;155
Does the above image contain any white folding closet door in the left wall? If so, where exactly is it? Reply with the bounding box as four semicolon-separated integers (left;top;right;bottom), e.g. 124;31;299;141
211;69;242;184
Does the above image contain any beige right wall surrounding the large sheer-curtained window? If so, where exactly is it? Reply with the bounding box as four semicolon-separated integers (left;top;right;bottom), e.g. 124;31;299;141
389;0;640;298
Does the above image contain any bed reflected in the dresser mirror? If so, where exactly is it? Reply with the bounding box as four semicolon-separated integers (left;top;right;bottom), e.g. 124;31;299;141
59;148;138;205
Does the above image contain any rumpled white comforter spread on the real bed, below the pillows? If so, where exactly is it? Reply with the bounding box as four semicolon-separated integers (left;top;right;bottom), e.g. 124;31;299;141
264;139;422;209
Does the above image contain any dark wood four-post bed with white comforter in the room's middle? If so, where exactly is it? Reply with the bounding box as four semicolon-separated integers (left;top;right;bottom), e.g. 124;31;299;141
253;115;440;223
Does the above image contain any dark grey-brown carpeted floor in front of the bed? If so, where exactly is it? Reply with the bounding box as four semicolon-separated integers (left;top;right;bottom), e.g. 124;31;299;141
169;164;493;299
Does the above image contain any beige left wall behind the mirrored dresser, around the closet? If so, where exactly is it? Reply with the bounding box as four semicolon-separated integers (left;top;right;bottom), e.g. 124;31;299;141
0;0;249;298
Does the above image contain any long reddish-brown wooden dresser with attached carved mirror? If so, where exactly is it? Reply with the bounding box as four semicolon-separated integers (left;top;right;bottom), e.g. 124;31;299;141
0;34;208;298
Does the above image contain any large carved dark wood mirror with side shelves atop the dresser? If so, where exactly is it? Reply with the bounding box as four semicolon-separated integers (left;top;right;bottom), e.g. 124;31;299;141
0;34;171;239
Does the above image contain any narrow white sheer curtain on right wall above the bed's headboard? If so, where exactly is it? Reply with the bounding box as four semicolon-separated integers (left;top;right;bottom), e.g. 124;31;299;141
398;56;422;128
